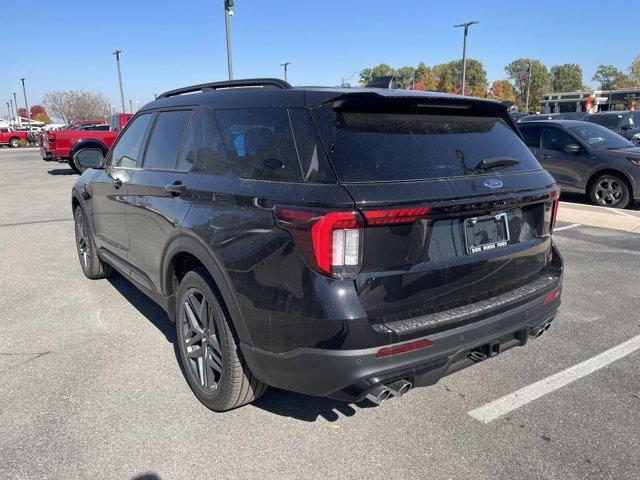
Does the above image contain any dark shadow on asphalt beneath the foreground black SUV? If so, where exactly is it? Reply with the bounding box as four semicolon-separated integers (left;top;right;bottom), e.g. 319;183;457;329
107;273;376;422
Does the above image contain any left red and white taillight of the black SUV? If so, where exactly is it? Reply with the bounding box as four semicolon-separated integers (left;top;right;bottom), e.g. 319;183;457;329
274;207;363;278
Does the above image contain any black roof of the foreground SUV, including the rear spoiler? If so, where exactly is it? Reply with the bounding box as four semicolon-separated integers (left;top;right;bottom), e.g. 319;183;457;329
140;79;506;113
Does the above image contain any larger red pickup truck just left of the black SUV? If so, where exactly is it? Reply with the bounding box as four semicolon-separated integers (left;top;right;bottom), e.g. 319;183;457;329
40;113;131;173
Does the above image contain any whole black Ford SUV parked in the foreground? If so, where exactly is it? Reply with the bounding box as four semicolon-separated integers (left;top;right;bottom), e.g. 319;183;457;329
72;79;562;410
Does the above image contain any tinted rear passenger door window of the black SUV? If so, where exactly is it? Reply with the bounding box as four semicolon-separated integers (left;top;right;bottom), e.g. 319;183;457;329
144;110;191;170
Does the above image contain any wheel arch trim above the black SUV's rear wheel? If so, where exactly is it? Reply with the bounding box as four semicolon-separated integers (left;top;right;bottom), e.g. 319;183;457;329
160;230;252;345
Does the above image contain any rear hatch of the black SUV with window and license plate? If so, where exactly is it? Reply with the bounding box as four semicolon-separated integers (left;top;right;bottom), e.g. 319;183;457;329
312;98;557;333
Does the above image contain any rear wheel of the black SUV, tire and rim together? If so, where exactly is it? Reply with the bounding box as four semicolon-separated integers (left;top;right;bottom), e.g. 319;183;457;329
176;268;267;412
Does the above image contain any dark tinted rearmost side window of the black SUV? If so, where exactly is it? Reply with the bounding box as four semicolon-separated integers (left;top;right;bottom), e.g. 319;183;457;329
216;109;302;182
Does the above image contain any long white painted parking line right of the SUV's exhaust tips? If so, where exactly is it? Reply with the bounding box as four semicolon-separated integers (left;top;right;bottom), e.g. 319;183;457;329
467;335;640;423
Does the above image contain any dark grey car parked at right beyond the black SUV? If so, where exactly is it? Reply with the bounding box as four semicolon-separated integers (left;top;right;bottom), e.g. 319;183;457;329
518;120;640;208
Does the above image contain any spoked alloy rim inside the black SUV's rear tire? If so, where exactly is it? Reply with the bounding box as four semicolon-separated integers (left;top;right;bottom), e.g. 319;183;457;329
180;288;222;394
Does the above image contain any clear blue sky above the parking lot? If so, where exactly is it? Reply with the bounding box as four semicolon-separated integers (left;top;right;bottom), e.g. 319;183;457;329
0;0;640;114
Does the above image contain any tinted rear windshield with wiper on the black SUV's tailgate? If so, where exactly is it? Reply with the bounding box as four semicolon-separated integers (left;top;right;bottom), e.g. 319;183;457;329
314;106;541;182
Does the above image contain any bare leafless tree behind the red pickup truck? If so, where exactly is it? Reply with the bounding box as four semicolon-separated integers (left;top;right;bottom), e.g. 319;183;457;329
44;90;109;124
